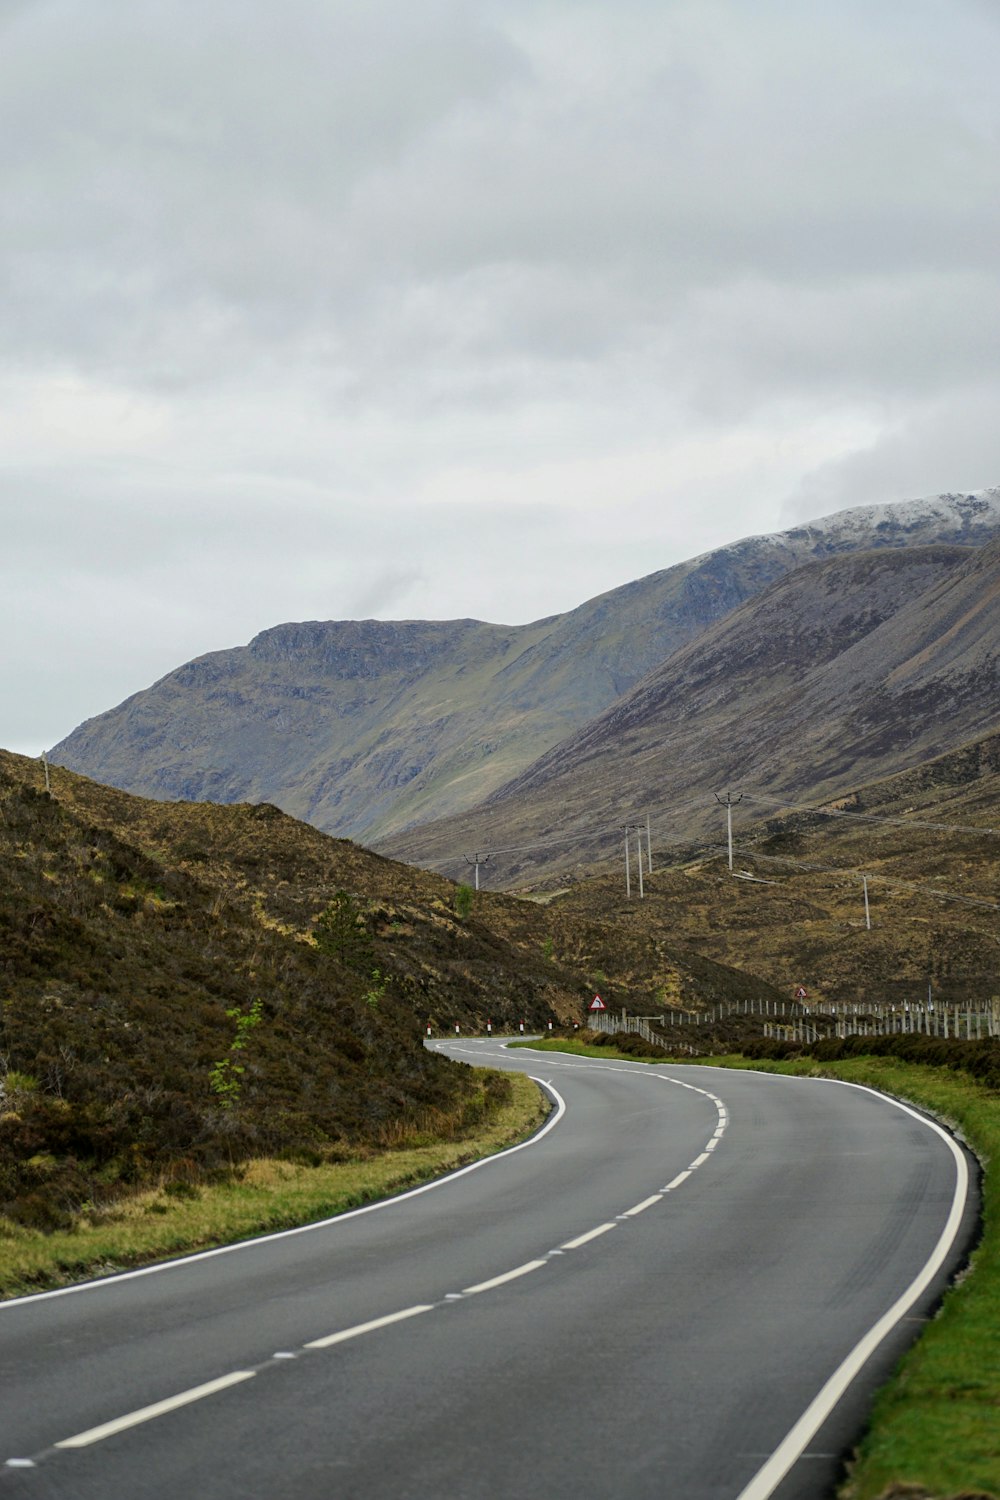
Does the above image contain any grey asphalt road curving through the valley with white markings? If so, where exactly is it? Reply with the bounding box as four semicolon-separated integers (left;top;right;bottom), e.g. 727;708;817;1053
0;1041;976;1500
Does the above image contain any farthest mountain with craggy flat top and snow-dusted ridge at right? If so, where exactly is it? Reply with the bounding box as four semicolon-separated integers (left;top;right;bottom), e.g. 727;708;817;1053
51;489;1000;842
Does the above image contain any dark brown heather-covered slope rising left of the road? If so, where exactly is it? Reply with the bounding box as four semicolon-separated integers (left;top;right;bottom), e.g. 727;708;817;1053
0;752;577;1227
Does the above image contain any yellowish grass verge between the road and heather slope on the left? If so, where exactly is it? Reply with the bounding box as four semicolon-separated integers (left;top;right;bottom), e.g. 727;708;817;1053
0;1074;549;1298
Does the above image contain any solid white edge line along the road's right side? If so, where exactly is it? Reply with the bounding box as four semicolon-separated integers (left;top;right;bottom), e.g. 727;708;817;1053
736;1079;969;1500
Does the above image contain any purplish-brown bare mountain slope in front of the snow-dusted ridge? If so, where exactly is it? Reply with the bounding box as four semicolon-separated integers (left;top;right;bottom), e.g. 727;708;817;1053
387;540;1000;881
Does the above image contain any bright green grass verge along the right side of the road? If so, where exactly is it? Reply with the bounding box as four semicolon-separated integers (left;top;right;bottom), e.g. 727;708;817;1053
521;1038;1000;1500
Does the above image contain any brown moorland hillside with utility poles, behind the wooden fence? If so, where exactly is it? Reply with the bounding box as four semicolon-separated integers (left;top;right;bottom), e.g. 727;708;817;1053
524;735;1000;1010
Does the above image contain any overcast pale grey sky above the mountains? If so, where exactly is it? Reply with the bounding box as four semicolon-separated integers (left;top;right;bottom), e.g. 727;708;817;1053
0;0;1000;753
